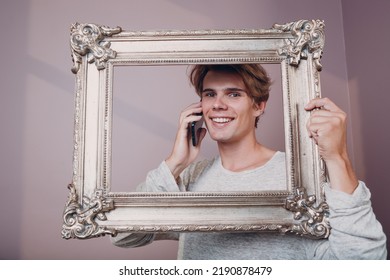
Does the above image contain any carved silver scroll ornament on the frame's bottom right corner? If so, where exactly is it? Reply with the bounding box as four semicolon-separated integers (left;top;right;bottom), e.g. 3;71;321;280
286;188;331;238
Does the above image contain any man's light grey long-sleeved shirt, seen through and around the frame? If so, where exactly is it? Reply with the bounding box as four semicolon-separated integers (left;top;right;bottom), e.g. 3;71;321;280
112;152;387;260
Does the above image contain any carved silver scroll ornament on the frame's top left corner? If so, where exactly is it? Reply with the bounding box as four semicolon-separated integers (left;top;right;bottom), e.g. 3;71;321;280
70;23;122;74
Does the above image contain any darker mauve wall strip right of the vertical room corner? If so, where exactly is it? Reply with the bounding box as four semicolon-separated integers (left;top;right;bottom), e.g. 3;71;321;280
342;0;390;258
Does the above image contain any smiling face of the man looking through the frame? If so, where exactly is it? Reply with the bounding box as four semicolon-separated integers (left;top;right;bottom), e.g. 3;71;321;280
202;71;260;143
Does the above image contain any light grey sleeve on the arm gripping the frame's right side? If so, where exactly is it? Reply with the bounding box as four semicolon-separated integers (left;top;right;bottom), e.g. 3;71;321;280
309;181;387;259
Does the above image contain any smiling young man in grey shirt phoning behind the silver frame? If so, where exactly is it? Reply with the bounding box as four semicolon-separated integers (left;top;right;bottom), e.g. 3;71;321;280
112;64;387;259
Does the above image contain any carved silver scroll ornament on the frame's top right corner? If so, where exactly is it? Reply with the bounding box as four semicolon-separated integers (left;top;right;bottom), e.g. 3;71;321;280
273;19;325;71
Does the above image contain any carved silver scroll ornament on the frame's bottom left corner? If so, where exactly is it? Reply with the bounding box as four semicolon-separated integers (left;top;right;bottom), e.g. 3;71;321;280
61;184;115;239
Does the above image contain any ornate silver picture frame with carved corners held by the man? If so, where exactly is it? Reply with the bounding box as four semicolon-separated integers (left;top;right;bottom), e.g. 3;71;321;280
62;20;330;239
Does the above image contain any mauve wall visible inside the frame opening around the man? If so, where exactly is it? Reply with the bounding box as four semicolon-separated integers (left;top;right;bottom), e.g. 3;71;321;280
111;64;285;192
